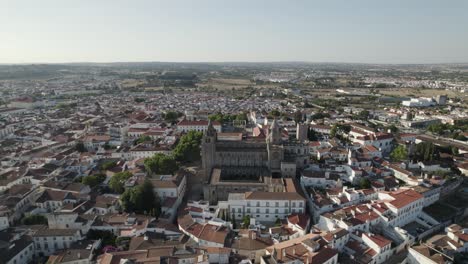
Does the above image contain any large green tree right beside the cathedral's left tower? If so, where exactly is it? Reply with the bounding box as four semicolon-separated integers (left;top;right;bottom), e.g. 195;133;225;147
173;131;203;162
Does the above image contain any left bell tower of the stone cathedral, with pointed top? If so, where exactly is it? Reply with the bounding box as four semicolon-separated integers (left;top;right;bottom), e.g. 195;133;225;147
201;120;217;181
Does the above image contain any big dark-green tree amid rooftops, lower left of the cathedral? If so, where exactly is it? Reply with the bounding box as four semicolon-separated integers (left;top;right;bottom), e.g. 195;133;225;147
120;180;161;217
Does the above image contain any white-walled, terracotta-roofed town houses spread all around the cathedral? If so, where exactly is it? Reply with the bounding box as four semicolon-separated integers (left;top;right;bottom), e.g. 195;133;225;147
0;83;468;264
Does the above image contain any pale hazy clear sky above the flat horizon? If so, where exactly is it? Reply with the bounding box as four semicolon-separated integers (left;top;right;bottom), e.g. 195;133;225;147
0;0;468;64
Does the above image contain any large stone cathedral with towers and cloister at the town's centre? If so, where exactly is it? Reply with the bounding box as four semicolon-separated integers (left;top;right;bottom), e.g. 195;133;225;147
201;120;309;202
